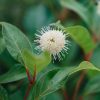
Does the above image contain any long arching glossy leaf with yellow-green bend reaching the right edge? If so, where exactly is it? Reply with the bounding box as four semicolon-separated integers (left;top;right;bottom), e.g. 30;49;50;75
48;61;100;95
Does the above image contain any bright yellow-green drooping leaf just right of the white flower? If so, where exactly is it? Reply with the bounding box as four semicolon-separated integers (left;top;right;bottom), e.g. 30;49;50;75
65;26;95;54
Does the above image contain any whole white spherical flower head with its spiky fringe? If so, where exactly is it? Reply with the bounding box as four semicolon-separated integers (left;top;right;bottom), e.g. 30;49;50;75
35;26;69;60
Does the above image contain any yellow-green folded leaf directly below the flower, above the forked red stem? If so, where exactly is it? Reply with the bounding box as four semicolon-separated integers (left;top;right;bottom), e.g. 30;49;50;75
22;50;51;75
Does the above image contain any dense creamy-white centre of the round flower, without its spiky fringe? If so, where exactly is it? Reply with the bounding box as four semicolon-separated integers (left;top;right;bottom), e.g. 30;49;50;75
40;30;65;54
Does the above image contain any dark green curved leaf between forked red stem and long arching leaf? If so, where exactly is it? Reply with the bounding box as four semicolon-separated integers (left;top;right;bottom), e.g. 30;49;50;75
28;66;60;100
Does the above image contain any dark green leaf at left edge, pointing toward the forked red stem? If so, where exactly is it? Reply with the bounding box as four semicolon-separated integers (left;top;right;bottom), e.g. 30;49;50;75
0;65;27;84
